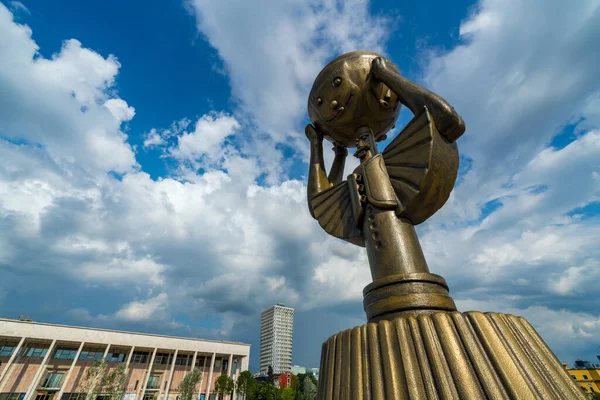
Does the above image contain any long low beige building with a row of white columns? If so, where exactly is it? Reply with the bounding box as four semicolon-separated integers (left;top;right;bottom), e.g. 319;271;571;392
0;318;250;400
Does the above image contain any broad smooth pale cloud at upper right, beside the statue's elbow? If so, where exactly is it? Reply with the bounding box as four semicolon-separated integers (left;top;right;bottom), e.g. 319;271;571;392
425;0;600;223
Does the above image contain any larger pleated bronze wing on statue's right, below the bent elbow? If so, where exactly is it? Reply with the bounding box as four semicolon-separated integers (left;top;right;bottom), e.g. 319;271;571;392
382;108;458;225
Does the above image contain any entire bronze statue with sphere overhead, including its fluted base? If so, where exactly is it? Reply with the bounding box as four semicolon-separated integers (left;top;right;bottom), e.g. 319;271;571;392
305;51;585;399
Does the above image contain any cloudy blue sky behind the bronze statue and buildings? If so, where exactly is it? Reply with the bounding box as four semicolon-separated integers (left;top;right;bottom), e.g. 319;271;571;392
0;0;600;372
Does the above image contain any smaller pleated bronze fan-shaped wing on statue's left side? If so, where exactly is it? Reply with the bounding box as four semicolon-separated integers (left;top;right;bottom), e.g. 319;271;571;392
312;181;364;246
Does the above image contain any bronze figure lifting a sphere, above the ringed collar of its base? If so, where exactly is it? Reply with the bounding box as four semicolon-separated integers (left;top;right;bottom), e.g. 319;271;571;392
306;52;465;290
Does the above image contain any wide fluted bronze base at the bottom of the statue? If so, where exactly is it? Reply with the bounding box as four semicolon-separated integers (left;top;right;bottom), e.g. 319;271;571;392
317;310;586;400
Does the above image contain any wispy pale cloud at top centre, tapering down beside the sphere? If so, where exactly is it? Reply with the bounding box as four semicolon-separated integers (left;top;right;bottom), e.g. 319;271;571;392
188;0;390;172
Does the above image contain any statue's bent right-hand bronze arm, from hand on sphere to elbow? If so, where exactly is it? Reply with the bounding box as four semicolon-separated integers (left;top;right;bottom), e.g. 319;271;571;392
371;57;465;142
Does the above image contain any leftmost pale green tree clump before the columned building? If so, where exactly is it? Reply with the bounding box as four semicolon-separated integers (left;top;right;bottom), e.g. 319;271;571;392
79;358;127;400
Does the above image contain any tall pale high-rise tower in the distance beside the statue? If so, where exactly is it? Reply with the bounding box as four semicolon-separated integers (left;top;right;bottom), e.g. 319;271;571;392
260;303;294;375
